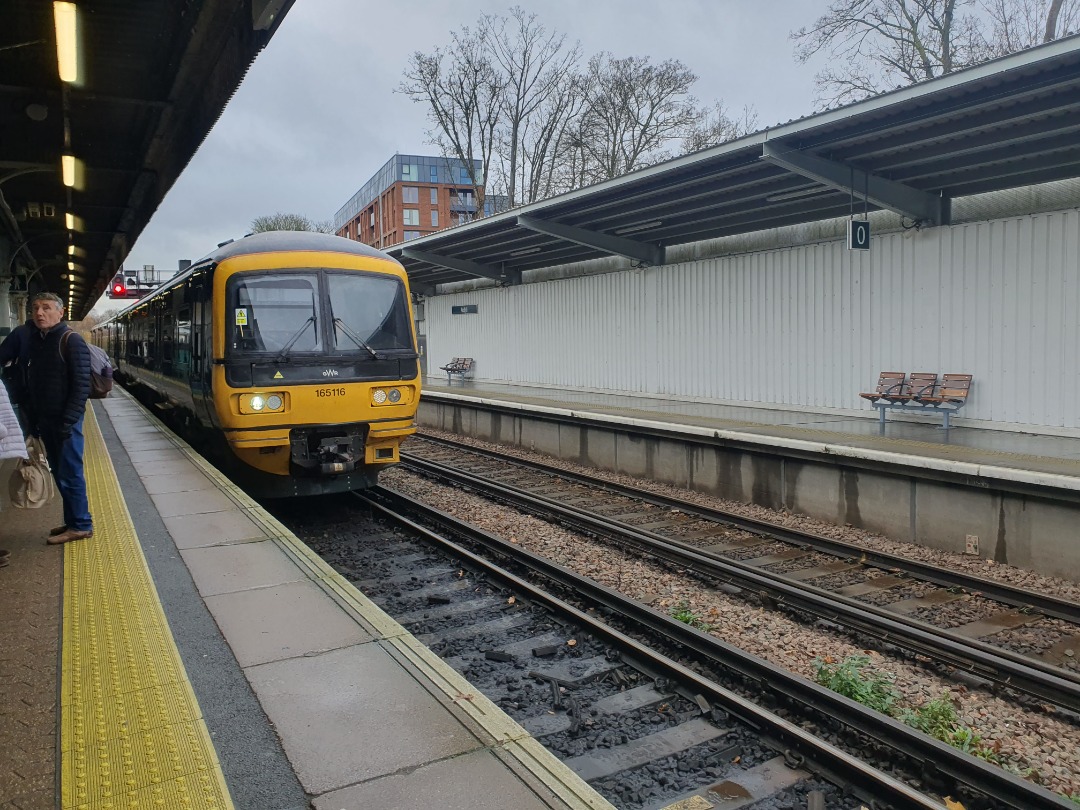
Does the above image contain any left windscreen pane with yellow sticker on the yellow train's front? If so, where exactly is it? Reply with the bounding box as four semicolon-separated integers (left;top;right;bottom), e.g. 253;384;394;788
226;272;323;352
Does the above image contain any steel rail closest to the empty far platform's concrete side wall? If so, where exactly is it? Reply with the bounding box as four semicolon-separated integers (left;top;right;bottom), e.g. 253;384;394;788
410;436;1080;624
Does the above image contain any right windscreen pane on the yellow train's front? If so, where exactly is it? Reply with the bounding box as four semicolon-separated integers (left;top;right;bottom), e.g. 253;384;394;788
326;272;413;352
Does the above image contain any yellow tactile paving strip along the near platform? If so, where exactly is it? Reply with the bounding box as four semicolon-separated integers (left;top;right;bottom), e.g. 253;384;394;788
60;408;232;810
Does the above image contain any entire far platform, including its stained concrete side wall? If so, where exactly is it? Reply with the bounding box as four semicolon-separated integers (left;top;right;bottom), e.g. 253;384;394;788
406;377;1080;582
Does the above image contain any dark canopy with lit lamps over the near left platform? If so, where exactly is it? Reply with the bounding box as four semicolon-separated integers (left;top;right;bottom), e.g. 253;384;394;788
0;0;294;320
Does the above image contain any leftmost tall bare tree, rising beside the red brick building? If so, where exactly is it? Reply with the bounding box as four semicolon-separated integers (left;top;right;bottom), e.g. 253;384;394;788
399;27;503;216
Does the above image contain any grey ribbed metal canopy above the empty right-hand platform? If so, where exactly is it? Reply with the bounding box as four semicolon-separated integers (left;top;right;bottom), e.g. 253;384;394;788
388;36;1080;292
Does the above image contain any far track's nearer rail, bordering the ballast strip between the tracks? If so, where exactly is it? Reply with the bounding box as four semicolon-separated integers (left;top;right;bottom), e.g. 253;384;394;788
406;458;1080;713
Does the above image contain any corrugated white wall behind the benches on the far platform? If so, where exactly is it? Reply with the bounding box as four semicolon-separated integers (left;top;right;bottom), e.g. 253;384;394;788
426;210;1080;429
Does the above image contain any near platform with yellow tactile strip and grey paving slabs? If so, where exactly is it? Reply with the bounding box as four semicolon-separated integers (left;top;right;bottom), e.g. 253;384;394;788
0;389;611;810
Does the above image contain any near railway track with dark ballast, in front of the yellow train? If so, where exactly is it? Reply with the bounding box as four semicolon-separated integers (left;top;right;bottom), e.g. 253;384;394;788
265;489;1070;810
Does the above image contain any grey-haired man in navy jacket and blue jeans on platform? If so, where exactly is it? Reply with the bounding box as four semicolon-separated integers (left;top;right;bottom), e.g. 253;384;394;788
0;293;94;544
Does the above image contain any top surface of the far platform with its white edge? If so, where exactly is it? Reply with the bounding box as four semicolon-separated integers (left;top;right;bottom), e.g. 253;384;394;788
423;377;1080;494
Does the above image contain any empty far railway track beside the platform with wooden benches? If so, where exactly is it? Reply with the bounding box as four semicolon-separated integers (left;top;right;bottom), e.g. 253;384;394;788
403;437;1080;713
